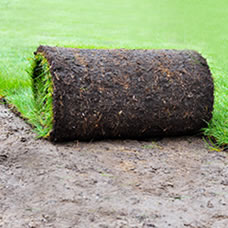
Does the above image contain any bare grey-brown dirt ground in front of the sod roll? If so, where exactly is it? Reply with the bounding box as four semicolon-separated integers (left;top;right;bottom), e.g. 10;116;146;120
0;105;228;228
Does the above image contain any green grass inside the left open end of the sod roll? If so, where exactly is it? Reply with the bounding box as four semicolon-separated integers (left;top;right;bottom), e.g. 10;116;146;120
32;54;53;138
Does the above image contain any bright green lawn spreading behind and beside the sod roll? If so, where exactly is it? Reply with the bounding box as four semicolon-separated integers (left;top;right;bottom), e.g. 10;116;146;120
0;0;228;145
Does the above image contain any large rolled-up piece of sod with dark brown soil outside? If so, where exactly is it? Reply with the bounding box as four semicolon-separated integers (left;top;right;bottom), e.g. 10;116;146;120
33;46;214;141
